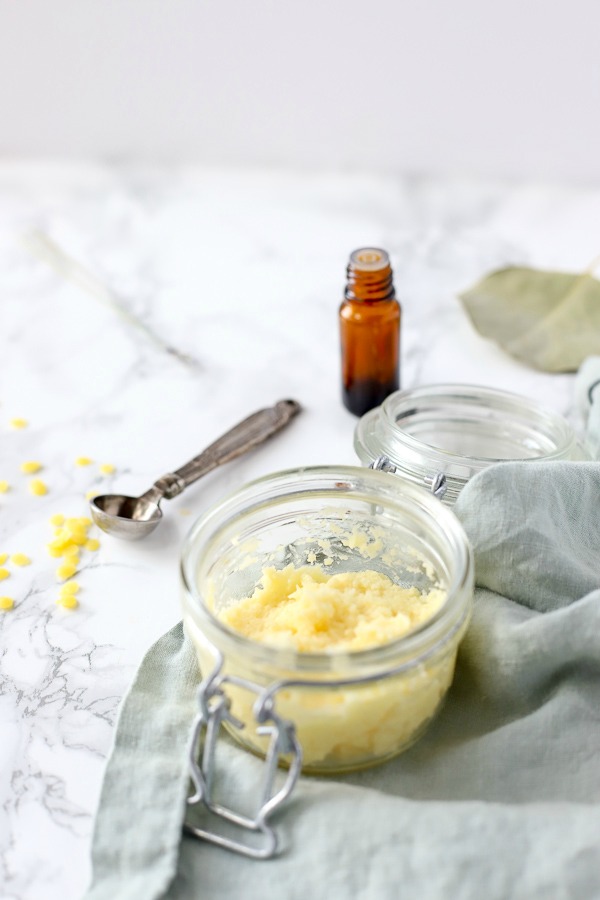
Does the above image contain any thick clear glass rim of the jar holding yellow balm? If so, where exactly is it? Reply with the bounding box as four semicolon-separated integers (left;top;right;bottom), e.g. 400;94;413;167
180;466;474;675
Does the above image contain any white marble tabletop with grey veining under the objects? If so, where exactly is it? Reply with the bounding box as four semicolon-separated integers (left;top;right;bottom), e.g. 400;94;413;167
0;162;600;900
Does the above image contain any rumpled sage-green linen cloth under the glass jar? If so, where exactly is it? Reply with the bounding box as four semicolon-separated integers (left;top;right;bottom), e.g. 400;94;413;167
86;392;600;900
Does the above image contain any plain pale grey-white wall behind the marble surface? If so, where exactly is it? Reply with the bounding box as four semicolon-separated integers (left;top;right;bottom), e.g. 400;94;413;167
0;0;600;183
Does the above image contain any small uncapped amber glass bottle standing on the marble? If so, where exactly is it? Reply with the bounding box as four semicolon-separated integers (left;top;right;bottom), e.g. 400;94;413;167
340;247;401;416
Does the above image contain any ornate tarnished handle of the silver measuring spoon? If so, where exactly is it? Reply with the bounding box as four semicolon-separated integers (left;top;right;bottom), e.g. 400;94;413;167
157;400;302;500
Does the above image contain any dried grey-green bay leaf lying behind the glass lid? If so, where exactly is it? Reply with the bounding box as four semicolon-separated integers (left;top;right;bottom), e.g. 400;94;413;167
459;266;600;372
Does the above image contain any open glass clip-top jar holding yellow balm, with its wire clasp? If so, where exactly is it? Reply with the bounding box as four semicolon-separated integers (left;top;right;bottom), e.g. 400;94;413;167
181;467;473;856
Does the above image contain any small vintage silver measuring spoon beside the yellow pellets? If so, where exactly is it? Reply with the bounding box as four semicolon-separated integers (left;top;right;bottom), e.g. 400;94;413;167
90;400;302;541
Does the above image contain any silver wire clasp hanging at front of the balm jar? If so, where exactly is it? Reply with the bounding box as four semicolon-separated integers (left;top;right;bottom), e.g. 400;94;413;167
184;653;302;859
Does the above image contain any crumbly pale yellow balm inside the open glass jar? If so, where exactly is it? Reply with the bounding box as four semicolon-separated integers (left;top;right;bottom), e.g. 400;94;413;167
209;560;454;772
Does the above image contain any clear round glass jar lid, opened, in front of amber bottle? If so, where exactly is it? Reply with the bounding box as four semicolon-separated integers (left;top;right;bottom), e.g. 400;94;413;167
354;384;585;505
